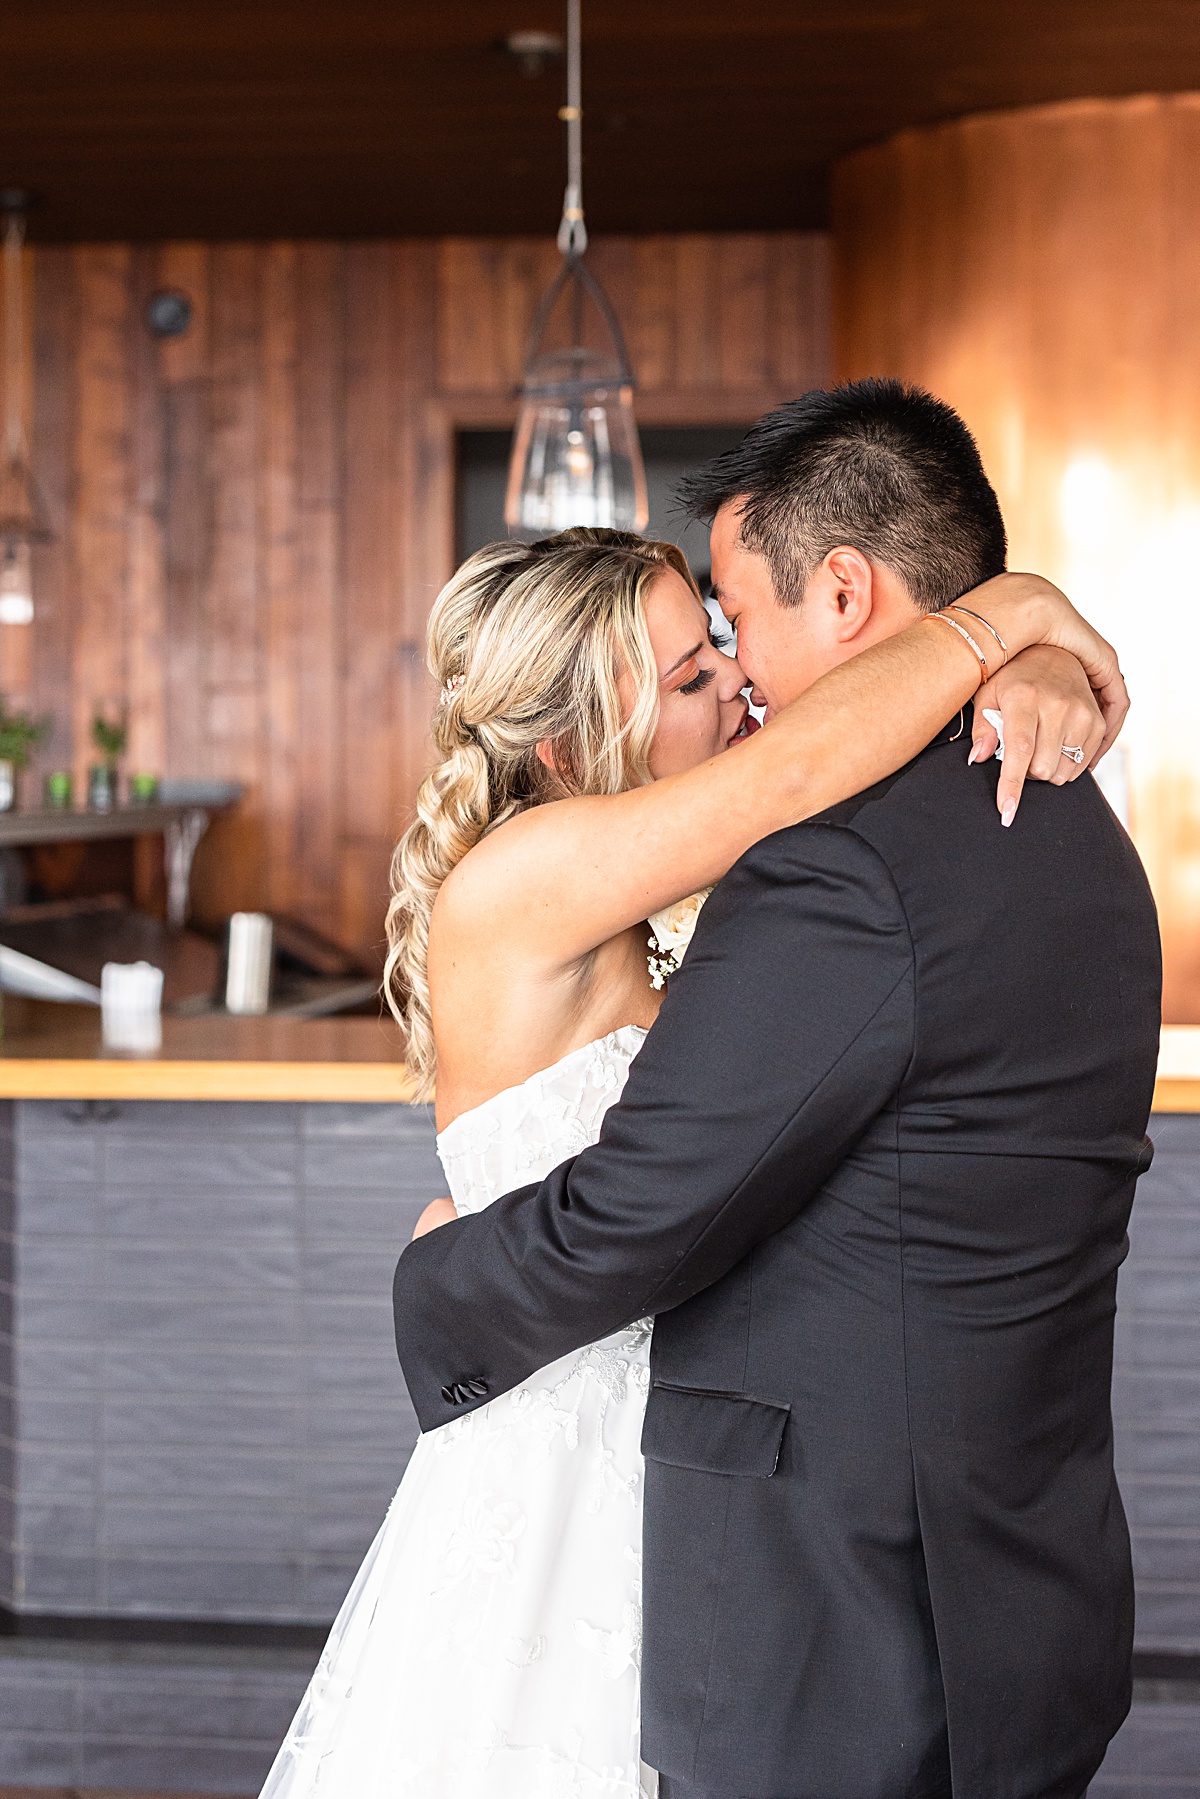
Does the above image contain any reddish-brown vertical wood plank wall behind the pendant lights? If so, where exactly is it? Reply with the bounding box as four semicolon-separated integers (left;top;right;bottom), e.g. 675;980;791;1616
9;234;829;946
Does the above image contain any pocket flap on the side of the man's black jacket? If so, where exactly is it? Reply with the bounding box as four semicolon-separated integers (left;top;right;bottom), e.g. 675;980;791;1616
642;1380;792;1479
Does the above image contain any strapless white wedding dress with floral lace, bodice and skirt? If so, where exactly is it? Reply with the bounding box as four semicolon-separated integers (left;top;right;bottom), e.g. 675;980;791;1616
263;1025;655;1799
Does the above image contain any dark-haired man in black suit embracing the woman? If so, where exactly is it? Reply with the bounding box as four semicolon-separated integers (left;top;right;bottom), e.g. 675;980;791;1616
396;381;1159;1799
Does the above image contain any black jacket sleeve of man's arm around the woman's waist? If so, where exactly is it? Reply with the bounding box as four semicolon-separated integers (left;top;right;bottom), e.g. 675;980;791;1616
394;824;914;1430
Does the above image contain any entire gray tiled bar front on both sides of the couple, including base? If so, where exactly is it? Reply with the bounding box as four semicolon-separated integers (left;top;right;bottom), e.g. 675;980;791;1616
0;1101;1200;1799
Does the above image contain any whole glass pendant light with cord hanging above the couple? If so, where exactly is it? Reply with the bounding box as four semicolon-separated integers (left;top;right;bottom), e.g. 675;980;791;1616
504;0;649;538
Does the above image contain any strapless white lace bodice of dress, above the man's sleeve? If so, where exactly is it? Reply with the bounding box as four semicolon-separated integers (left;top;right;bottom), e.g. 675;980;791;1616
437;1024;646;1214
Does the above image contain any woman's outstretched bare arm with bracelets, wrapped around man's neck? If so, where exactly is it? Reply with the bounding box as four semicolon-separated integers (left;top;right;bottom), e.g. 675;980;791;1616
434;576;1128;966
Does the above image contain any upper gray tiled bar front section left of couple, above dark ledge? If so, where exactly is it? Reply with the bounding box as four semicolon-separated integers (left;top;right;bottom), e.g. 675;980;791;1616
0;1101;444;1626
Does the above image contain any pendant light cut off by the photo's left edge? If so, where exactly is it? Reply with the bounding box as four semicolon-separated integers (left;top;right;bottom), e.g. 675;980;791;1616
0;187;50;624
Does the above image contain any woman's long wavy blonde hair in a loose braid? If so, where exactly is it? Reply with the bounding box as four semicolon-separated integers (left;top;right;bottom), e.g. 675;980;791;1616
383;529;700;1097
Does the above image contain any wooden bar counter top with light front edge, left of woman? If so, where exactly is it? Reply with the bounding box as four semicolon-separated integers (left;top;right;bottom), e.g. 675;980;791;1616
0;997;420;1103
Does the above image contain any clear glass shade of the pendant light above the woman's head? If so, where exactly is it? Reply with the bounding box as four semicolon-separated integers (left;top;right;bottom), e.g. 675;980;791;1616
504;349;649;538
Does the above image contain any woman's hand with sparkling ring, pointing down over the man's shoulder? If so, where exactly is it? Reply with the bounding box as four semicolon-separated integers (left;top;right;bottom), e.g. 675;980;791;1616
972;644;1105;824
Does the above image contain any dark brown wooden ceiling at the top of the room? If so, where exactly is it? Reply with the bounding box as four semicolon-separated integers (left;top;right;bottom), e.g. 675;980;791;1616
0;0;1200;241
